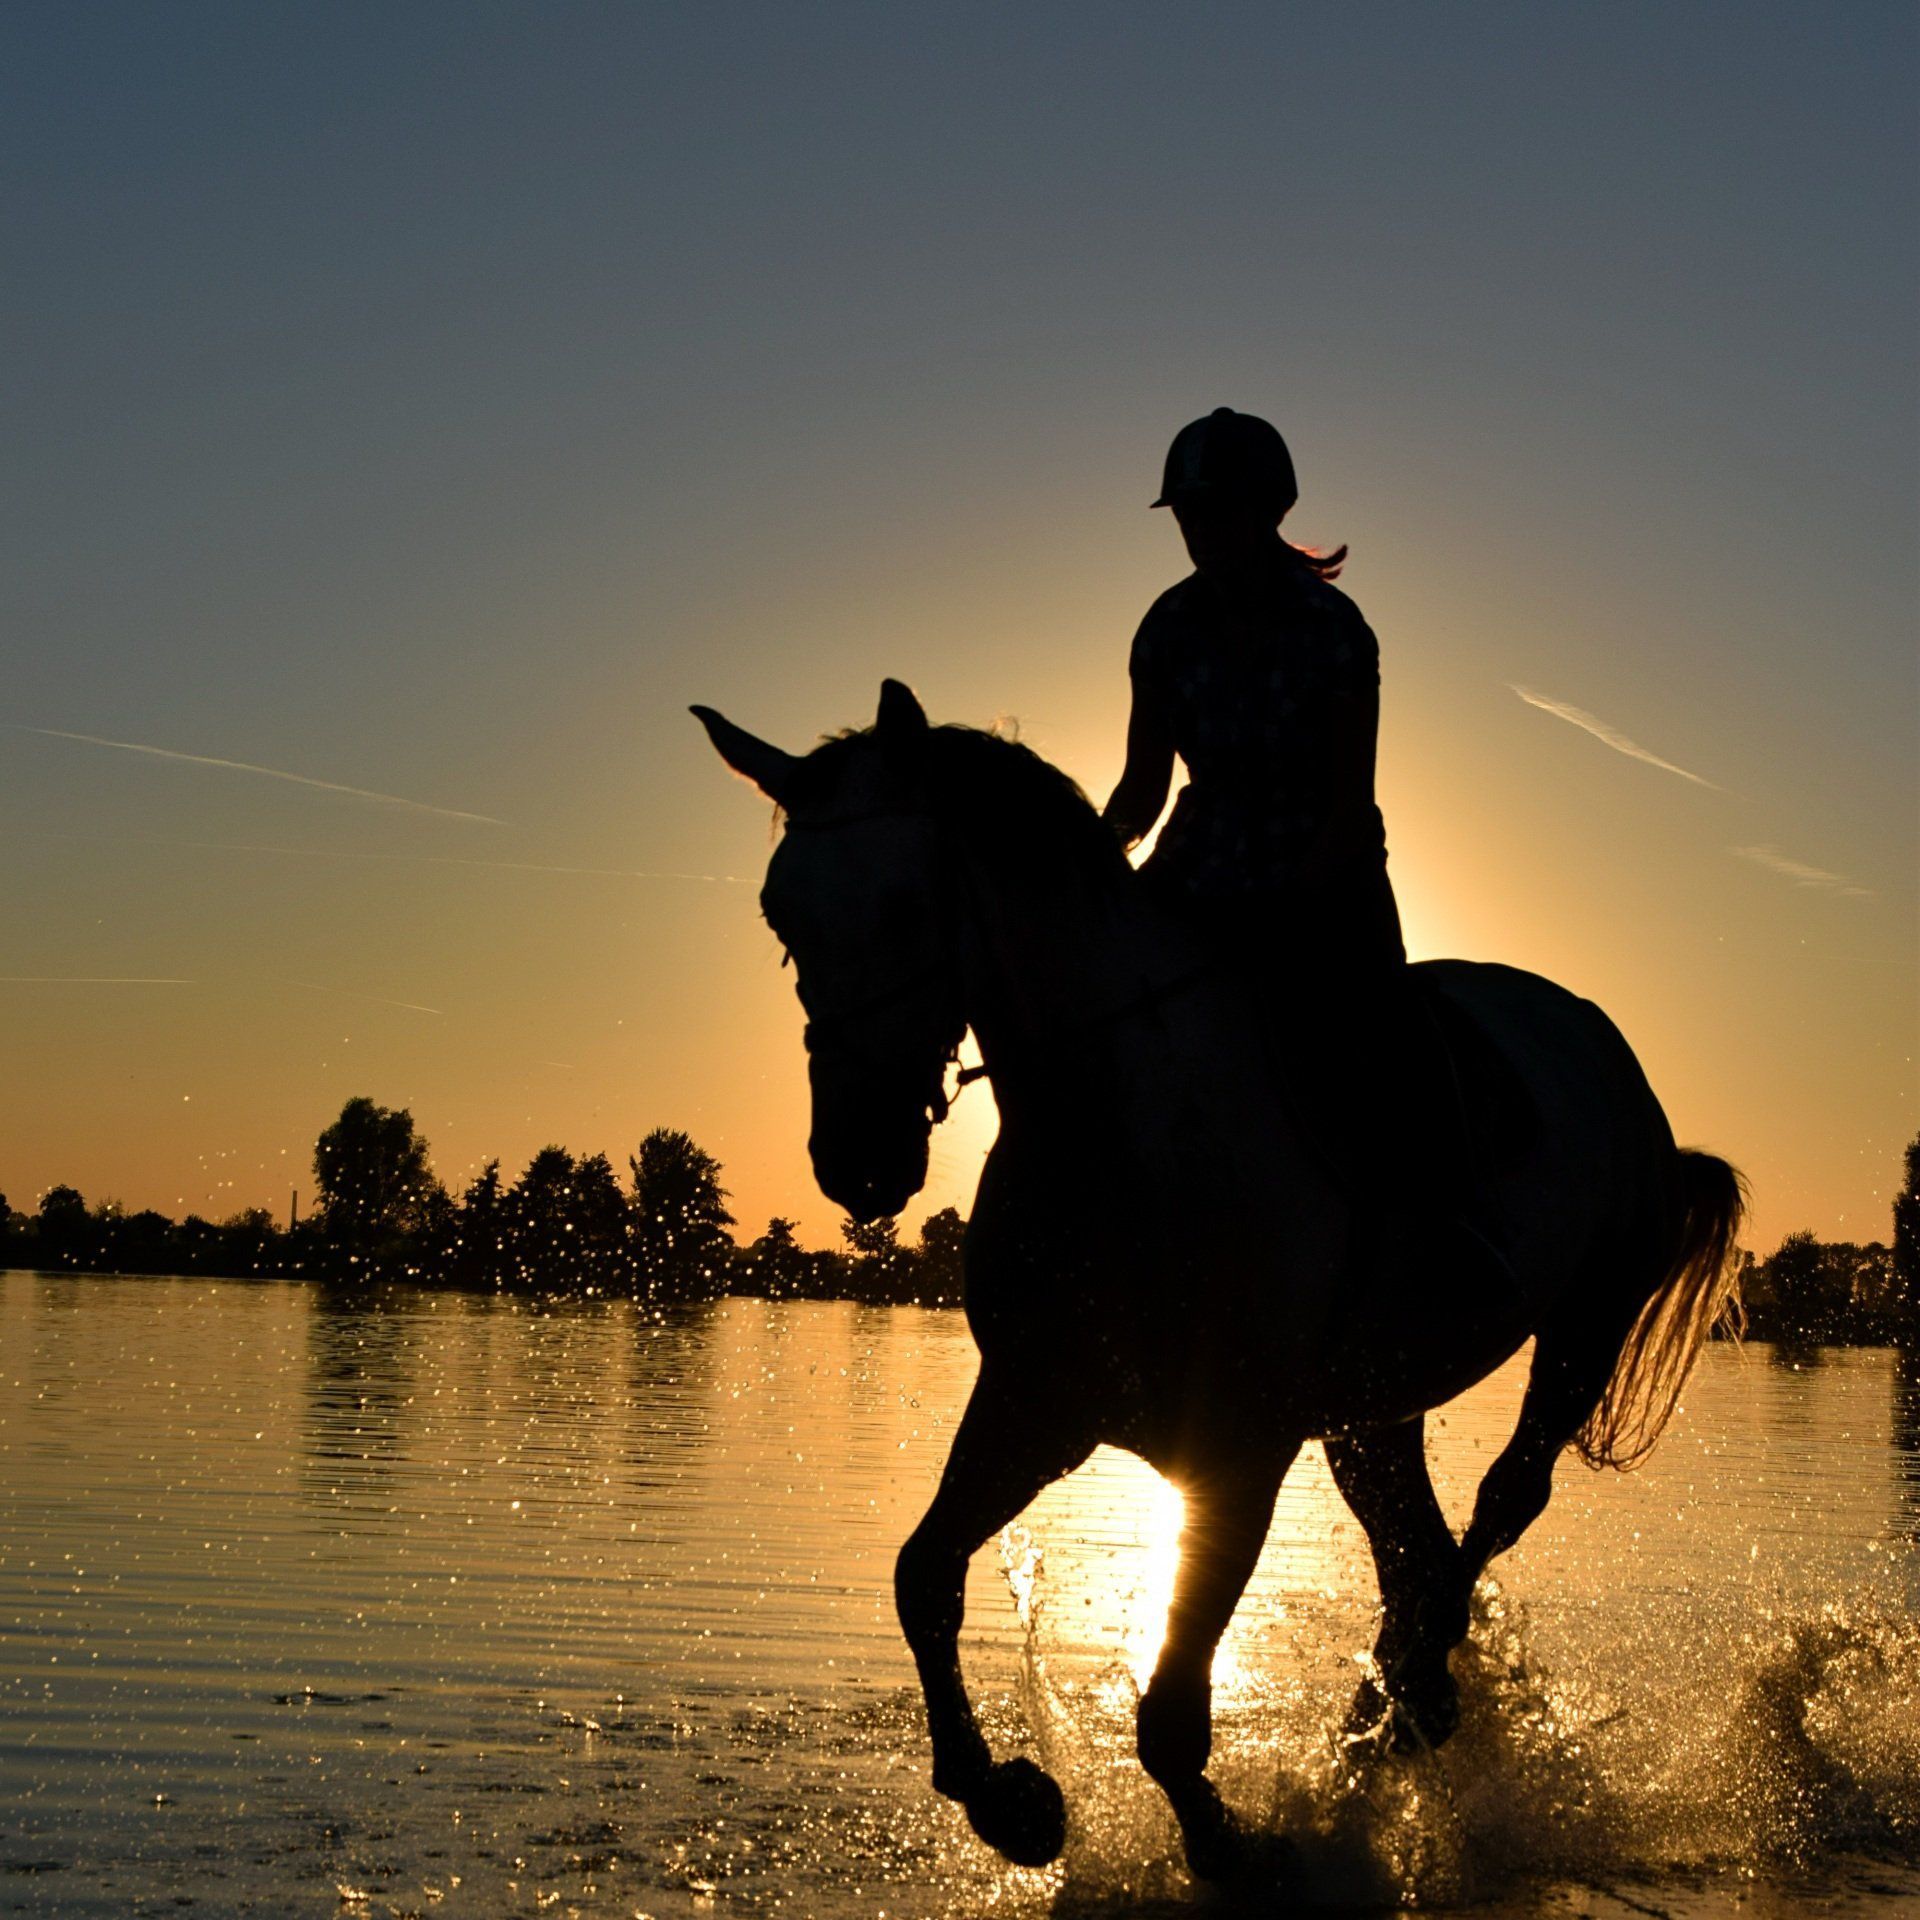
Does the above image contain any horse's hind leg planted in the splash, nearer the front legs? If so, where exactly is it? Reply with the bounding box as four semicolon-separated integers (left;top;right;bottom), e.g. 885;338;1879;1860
1327;1419;1469;1747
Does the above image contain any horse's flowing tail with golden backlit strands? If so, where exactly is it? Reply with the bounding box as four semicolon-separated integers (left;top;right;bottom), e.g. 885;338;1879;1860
1572;1146;1747;1473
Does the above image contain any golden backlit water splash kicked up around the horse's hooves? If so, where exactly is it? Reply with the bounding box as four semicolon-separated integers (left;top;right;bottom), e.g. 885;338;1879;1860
1002;1566;1920;1914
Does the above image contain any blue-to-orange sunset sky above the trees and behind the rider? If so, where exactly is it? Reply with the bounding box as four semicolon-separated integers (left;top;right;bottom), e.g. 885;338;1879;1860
0;0;1920;1250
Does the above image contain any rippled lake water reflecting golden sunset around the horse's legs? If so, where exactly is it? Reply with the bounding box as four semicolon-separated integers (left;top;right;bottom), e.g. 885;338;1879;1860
0;1273;1920;1920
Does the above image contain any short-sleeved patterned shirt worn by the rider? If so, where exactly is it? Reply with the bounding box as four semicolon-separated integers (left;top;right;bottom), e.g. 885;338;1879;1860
1129;566;1386;897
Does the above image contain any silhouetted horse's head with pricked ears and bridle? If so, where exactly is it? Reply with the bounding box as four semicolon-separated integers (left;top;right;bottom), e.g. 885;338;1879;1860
693;680;966;1219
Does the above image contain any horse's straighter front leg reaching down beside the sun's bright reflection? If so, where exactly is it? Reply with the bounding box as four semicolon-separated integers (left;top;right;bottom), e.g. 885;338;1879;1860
1139;1448;1294;1880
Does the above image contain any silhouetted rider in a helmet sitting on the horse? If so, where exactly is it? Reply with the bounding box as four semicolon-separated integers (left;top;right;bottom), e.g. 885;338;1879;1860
1104;407;1507;1281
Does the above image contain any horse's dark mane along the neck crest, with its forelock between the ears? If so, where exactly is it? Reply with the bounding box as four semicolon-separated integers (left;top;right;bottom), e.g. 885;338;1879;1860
793;724;1133;881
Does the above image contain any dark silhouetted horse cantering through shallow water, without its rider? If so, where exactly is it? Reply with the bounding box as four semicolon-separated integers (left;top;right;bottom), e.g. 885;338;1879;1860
695;682;1740;1876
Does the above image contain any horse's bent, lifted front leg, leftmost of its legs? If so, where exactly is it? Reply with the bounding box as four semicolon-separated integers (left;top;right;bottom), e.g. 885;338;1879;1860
893;1373;1092;1866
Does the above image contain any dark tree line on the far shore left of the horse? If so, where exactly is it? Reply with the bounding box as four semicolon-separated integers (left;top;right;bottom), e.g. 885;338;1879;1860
0;1098;966;1306
